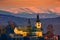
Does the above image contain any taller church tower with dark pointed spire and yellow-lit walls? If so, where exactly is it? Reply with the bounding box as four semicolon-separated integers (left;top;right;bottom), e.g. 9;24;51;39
35;14;43;37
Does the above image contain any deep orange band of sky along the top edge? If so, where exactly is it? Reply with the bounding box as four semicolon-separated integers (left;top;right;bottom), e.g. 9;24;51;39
0;0;60;7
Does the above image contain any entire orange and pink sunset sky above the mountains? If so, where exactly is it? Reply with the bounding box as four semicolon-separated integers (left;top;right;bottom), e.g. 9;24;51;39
0;0;60;13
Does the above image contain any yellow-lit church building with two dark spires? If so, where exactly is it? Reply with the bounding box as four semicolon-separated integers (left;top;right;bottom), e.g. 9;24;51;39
14;15;43;37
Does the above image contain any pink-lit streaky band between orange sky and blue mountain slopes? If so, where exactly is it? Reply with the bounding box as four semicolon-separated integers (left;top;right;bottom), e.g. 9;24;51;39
2;7;60;14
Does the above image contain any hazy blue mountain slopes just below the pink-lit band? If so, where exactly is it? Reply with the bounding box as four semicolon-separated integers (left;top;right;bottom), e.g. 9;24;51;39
0;10;60;19
